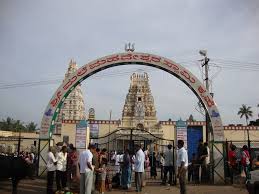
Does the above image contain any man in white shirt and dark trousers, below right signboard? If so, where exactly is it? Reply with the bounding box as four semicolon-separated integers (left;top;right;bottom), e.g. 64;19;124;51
176;140;188;194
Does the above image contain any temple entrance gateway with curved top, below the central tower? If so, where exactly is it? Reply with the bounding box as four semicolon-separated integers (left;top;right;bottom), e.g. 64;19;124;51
93;127;176;185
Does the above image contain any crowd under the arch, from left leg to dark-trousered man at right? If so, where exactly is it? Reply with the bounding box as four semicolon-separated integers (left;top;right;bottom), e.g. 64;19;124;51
47;140;188;194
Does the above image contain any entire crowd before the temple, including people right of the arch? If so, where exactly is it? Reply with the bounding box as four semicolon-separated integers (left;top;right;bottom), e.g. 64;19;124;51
47;140;259;194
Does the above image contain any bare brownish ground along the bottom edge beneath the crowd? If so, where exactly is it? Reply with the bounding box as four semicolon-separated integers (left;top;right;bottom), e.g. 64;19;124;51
0;179;248;194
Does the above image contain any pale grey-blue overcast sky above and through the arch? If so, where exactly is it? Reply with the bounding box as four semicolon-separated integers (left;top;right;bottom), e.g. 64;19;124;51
0;0;259;125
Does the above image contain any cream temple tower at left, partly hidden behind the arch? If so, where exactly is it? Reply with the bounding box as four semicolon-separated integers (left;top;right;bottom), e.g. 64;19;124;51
55;60;86;134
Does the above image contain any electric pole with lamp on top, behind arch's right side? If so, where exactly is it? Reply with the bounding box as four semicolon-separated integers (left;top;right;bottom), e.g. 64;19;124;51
199;50;210;142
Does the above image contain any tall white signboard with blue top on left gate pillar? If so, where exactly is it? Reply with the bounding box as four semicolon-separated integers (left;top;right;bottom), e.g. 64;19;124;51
76;120;87;149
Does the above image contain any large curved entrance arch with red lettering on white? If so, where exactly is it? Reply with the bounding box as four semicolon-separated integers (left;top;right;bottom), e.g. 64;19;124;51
40;52;224;141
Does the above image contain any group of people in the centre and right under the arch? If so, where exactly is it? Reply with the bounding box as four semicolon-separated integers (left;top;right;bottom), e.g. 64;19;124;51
111;140;188;193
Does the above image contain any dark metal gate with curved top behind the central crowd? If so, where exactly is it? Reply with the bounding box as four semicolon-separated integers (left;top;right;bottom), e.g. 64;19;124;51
91;128;176;184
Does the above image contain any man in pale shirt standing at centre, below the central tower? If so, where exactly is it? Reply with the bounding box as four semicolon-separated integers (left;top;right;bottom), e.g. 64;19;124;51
134;145;145;192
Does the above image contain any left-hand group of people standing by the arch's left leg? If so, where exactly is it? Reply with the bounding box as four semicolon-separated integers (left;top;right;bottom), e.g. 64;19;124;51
47;144;111;194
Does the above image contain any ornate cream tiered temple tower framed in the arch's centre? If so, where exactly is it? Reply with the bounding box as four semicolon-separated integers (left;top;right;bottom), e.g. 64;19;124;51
121;73;157;130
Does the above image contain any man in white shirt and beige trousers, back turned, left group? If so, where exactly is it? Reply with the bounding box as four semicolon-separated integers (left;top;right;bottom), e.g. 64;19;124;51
79;145;95;194
